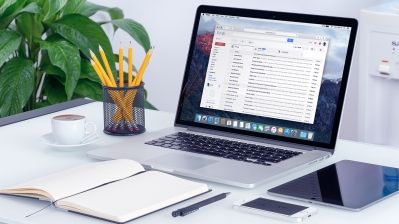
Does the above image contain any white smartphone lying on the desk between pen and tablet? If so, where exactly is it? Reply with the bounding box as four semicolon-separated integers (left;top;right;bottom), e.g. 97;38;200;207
233;197;317;222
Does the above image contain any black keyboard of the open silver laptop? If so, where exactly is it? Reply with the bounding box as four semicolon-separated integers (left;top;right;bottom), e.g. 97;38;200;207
145;132;302;166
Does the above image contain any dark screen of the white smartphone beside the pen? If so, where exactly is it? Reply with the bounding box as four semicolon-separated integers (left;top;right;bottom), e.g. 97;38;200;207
242;198;307;216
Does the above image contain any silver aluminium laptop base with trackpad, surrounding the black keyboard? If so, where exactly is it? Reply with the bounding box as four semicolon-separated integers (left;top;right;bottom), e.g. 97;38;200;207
88;127;331;188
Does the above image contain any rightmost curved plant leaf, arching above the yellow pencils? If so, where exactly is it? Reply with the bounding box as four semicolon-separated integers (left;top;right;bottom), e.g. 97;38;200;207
111;19;151;52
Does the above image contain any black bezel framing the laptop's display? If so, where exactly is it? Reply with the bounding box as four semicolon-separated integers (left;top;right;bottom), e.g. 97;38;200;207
175;5;358;151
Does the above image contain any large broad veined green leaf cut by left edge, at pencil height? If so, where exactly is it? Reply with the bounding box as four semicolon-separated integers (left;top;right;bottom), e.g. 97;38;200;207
0;58;35;117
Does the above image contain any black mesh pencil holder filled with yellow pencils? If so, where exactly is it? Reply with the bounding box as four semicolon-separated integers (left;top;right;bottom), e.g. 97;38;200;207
103;83;145;136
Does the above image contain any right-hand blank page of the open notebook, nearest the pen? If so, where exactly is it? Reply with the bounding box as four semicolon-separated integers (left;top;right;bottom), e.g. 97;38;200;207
57;171;208;222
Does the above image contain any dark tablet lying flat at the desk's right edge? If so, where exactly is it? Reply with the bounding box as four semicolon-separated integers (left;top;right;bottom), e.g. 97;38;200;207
268;160;399;210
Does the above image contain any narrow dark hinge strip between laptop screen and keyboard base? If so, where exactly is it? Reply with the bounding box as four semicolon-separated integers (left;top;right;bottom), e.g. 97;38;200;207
186;127;333;153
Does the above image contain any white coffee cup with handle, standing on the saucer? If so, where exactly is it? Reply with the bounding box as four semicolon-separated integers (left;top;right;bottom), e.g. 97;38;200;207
51;114;97;145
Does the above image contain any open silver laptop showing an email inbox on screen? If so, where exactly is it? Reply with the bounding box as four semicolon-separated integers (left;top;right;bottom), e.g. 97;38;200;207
88;6;357;188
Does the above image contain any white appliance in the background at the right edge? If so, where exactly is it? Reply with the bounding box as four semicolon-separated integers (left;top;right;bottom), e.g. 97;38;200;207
358;1;399;146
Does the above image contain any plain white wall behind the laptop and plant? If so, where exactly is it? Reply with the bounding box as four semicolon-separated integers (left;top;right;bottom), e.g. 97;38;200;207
91;0;384;139
